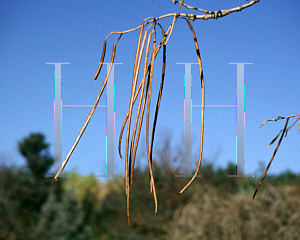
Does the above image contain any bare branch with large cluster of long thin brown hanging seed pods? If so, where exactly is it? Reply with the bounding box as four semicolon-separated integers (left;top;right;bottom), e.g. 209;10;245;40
53;0;259;225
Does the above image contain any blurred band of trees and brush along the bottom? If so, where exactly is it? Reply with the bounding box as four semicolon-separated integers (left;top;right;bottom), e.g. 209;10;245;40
0;133;300;240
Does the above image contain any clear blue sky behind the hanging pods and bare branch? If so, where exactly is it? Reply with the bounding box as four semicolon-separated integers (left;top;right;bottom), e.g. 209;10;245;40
0;0;300;181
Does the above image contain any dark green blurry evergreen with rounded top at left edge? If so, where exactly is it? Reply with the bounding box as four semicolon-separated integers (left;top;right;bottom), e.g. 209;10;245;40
0;133;62;239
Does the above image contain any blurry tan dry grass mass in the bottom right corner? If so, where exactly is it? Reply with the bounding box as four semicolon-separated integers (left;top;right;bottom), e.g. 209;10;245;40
168;184;300;240
